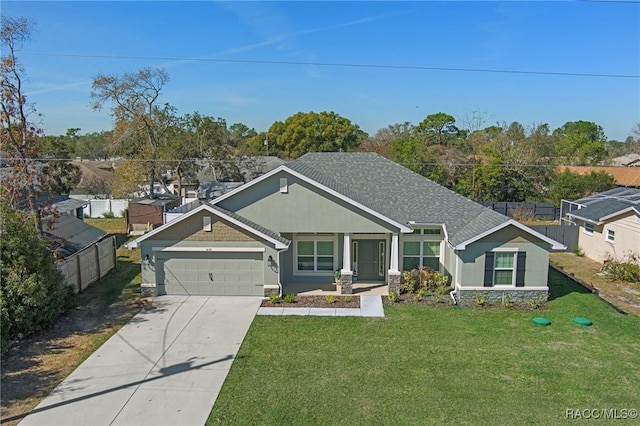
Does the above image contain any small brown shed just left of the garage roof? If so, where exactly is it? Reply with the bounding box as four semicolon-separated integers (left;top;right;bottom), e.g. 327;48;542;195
127;194;181;235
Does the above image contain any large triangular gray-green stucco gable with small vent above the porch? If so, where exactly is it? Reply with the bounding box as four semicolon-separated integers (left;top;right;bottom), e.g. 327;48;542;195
219;171;397;233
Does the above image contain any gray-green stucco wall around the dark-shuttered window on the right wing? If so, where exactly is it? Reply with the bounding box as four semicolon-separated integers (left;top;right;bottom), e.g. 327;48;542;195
458;226;549;288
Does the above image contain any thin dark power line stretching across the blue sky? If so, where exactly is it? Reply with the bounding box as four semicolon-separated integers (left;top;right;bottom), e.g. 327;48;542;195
22;52;640;79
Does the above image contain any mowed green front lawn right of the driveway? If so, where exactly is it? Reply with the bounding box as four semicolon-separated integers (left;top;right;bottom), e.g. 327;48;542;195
207;271;640;425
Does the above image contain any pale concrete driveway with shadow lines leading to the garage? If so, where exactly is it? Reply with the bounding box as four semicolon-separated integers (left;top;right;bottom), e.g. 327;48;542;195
20;296;260;426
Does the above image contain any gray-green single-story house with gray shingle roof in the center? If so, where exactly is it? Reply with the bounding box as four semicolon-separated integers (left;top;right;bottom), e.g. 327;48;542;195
129;153;565;303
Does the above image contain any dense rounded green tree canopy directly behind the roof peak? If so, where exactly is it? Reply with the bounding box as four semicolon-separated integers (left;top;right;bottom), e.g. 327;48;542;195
267;111;367;158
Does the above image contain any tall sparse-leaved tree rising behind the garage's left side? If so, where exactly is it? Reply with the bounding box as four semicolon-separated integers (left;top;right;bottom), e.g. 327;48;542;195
91;67;175;198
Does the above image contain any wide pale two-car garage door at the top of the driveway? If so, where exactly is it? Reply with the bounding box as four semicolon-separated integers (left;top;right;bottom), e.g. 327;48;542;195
156;251;264;296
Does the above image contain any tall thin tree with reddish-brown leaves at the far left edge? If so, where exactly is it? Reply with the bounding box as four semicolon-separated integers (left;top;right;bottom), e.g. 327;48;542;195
0;16;42;231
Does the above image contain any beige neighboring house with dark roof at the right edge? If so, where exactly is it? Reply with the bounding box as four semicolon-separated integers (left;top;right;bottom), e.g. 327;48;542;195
567;188;640;262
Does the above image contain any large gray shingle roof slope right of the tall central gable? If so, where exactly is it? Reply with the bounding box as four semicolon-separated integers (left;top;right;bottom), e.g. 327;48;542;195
286;152;509;245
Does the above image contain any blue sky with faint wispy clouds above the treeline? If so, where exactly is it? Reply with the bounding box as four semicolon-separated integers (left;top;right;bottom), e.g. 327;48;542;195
2;0;640;140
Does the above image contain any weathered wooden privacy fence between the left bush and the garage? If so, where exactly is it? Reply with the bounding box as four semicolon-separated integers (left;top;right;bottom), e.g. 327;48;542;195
57;235;116;293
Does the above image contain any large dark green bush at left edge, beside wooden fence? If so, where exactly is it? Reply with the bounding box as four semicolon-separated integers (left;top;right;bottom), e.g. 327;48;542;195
0;203;75;348
